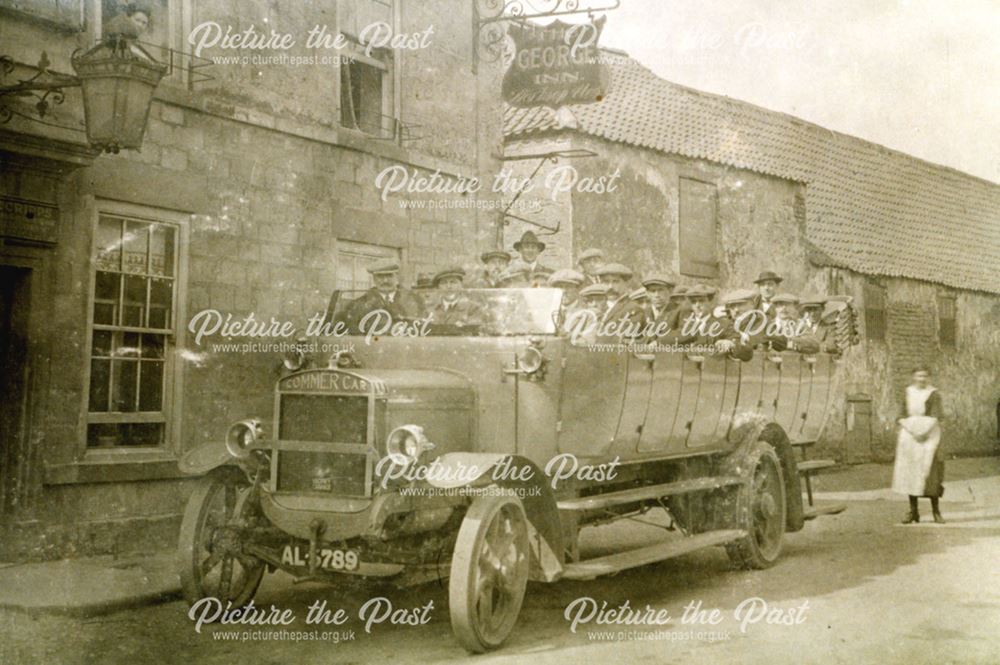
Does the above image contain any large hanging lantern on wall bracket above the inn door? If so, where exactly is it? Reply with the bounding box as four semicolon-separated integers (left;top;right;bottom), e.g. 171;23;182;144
72;34;167;153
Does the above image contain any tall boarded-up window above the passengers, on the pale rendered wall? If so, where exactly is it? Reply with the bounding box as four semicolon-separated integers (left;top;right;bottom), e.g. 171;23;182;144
678;178;719;277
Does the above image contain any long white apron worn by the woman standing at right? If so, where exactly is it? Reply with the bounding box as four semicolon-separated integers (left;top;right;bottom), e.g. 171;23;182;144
892;386;941;496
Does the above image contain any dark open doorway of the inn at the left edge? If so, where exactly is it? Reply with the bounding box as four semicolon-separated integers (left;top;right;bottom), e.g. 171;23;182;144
0;265;31;515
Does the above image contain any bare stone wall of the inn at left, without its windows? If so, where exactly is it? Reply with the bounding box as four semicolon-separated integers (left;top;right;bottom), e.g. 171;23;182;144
0;0;501;558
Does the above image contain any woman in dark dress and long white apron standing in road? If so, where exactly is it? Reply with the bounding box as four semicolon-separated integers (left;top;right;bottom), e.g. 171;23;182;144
892;367;944;524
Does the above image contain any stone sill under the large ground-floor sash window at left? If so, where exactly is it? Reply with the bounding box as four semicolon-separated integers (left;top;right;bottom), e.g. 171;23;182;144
44;451;191;485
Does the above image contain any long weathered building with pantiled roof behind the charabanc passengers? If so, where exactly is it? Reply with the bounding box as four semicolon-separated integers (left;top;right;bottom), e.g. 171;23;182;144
505;51;1000;462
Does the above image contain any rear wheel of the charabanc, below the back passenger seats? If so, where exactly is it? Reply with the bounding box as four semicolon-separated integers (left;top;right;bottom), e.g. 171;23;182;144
726;441;786;569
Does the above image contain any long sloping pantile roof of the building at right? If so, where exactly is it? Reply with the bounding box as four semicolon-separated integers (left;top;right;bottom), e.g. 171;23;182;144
504;52;1000;293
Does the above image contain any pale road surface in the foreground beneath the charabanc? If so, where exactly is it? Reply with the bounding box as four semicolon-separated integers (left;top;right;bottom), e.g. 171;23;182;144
0;478;1000;665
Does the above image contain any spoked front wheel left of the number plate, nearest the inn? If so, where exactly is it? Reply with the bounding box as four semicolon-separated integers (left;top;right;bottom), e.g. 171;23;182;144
179;472;264;607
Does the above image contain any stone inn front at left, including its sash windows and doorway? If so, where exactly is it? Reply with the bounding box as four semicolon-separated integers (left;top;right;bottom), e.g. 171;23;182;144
0;0;502;558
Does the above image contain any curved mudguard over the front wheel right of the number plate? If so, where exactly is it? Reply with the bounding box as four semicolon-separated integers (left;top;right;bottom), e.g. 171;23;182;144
427;453;565;582
